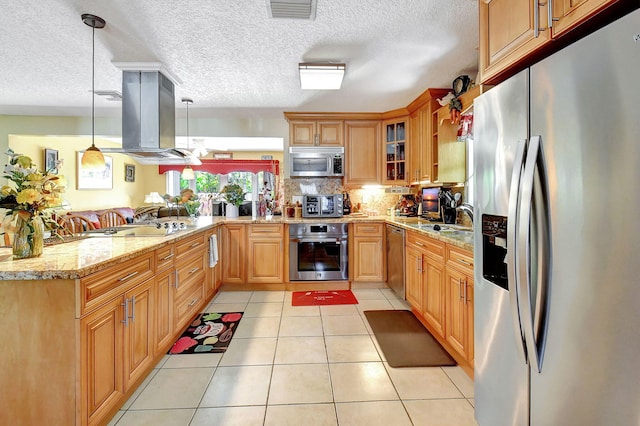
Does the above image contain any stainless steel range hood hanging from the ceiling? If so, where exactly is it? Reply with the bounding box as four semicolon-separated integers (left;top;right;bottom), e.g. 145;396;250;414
102;71;202;165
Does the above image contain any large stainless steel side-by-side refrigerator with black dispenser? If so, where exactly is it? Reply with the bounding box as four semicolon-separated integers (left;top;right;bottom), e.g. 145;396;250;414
474;10;640;426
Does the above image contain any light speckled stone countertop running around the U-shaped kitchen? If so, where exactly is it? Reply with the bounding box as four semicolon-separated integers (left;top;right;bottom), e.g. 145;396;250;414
0;216;473;280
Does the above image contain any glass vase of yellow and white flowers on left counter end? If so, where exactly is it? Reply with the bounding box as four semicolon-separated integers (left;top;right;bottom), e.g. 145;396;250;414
0;149;64;259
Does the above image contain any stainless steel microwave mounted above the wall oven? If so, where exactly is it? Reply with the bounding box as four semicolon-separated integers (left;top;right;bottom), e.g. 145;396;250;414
289;146;344;177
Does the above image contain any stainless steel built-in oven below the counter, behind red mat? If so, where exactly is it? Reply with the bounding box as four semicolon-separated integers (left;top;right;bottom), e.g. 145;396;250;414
289;223;349;281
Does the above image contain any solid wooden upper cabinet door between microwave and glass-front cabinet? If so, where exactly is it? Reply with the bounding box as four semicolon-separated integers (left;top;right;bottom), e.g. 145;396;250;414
344;120;382;186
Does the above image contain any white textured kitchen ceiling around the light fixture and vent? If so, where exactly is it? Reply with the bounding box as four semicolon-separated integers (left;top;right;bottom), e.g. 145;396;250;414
0;0;478;117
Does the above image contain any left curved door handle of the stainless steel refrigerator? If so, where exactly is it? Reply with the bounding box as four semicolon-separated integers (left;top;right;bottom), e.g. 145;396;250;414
505;140;527;364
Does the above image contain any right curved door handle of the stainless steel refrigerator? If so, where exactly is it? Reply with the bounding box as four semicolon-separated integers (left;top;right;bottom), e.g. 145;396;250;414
517;136;550;372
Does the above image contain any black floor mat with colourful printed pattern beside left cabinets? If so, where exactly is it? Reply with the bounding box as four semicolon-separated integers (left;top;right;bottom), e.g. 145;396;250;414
168;312;243;355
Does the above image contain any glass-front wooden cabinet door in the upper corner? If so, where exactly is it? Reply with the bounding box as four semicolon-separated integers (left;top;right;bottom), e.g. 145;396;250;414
384;119;407;185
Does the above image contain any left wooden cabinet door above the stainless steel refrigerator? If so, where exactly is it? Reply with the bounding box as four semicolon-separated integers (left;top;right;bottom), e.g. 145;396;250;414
479;0;551;84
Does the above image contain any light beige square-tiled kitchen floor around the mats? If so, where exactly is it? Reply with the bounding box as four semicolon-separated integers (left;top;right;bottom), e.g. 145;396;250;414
109;289;476;426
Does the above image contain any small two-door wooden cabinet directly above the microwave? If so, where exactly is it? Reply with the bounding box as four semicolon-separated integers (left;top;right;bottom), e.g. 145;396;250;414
289;120;344;146
